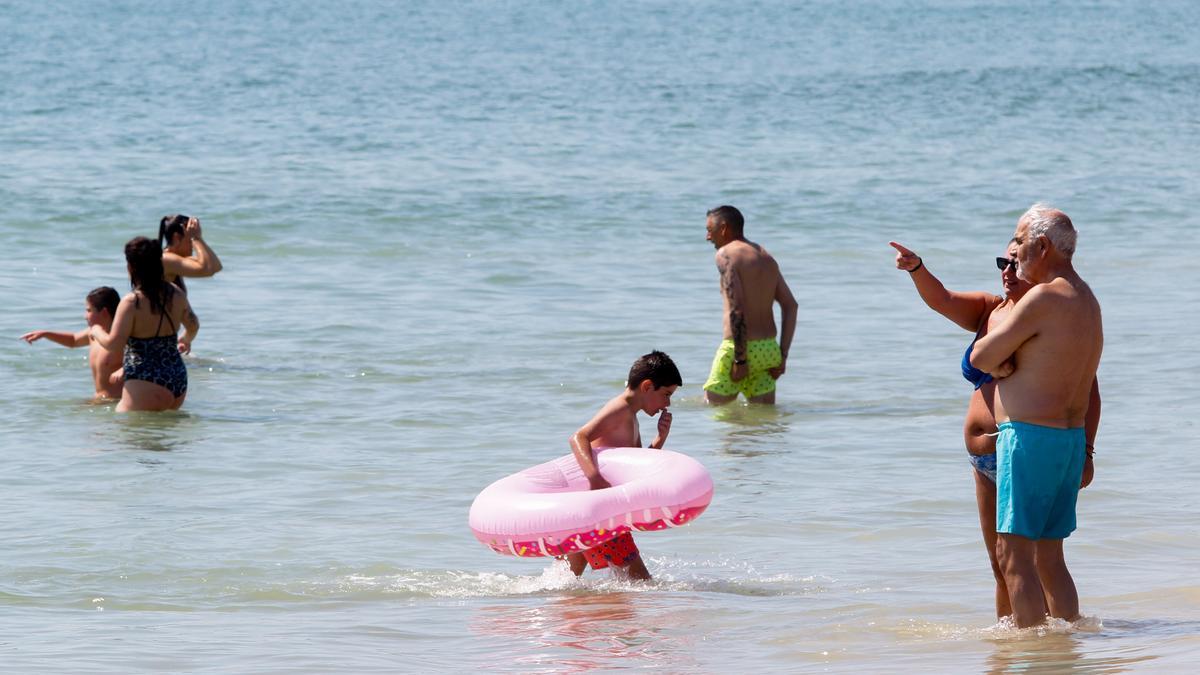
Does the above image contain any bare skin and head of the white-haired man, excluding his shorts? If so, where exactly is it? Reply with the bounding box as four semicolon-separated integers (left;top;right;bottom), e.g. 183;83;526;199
971;204;1104;628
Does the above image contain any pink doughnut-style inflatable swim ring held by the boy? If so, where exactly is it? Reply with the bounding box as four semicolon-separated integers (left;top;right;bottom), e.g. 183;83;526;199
469;448;713;557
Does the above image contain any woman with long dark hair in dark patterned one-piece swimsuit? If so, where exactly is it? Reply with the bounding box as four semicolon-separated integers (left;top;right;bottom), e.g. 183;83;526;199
91;237;200;412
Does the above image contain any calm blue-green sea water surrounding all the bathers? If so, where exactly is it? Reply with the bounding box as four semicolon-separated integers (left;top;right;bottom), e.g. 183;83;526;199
0;0;1200;673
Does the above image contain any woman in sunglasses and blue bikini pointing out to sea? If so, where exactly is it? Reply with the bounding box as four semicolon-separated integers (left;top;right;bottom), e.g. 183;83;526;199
889;241;1036;619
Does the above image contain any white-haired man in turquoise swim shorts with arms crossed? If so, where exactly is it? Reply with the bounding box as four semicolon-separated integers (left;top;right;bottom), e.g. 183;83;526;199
971;203;1104;628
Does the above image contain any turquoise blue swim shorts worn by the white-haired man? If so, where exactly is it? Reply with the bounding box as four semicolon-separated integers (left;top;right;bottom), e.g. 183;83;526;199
996;422;1085;539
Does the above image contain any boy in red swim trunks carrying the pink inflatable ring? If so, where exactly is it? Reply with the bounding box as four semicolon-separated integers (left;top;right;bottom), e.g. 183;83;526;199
566;352;683;580
